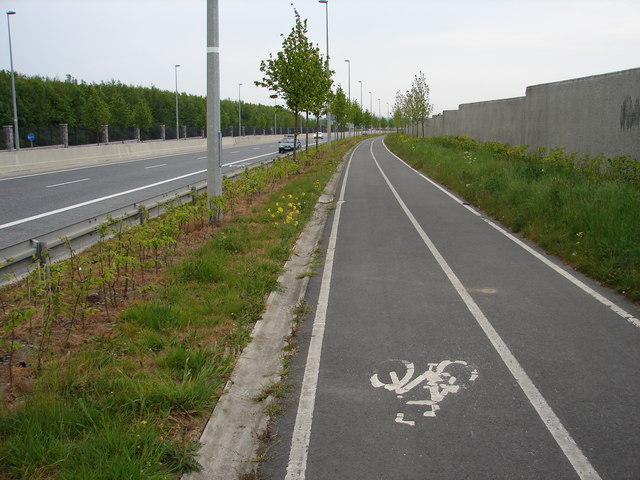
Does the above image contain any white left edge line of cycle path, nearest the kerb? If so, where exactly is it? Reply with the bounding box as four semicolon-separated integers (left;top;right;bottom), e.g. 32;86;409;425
285;142;358;480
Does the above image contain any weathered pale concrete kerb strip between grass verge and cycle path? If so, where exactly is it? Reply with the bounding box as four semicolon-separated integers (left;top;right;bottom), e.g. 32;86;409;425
183;147;344;480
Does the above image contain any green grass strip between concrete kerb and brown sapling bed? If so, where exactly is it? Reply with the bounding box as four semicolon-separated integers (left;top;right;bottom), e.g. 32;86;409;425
0;140;354;480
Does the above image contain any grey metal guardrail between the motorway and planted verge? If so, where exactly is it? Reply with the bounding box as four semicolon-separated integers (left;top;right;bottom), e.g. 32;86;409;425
0;159;273;285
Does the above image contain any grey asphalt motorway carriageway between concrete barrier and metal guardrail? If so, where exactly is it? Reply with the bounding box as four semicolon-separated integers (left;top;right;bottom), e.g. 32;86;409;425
0;142;298;248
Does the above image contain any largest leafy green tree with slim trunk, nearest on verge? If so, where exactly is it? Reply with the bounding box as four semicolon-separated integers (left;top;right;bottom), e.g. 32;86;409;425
255;8;331;158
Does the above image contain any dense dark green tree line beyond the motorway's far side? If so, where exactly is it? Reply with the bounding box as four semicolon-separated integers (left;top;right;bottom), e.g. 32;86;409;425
0;70;304;133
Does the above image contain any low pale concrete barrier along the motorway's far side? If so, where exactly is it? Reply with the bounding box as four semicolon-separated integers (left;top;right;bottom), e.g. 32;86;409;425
0;135;281;177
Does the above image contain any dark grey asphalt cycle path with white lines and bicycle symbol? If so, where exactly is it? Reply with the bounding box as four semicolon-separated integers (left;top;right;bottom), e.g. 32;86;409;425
260;138;640;480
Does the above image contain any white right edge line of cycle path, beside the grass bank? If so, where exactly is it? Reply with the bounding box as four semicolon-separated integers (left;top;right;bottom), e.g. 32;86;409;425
382;142;640;328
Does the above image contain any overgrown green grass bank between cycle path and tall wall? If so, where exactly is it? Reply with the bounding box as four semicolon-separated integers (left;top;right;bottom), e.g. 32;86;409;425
386;135;640;302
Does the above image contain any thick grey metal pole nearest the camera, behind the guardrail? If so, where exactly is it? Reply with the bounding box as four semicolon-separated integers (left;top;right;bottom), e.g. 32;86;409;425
207;0;222;221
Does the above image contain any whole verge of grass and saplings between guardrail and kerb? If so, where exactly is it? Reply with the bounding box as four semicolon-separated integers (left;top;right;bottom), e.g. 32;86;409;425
0;139;358;480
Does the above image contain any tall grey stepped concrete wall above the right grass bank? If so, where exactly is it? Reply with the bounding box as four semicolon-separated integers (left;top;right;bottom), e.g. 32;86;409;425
413;68;640;159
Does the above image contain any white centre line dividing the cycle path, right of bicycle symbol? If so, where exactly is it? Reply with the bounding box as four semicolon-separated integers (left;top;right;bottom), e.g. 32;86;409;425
371;142;601;480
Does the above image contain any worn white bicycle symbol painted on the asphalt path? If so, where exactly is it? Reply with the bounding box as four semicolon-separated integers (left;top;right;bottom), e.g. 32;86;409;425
369;360;478;426
